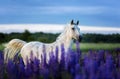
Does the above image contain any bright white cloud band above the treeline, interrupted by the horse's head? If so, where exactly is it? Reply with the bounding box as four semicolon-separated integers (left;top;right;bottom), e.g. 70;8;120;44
0;24;120;34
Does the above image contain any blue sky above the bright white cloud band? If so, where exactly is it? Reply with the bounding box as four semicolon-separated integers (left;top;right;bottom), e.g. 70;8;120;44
0;0;120;27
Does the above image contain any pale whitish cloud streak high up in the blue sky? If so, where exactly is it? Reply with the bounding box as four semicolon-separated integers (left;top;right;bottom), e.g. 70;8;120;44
38;6;104;14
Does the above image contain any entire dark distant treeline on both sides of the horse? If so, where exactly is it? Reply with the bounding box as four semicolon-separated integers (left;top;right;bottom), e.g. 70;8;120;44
0;30;120;43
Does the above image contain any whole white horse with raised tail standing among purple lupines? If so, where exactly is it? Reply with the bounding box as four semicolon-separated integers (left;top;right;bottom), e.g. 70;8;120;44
4;20;81;64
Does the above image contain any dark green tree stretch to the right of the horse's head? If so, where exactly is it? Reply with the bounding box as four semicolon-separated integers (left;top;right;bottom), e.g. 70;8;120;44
82;34;120;43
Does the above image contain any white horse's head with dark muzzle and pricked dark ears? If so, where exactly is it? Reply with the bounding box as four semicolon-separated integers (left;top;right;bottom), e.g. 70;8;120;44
67;20;82;42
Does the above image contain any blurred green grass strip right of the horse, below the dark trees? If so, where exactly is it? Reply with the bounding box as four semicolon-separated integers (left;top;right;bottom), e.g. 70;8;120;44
73;43;120;52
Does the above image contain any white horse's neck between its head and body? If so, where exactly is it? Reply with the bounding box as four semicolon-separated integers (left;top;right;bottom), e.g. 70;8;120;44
56;32;72;50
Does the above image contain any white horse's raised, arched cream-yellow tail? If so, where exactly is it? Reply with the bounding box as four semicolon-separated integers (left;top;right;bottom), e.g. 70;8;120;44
4;39;26;63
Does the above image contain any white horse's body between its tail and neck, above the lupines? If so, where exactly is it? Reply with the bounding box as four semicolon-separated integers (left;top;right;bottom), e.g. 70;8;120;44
20;41;53;64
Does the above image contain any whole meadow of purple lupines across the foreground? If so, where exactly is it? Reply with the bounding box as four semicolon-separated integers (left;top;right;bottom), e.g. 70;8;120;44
0;44;120;79
